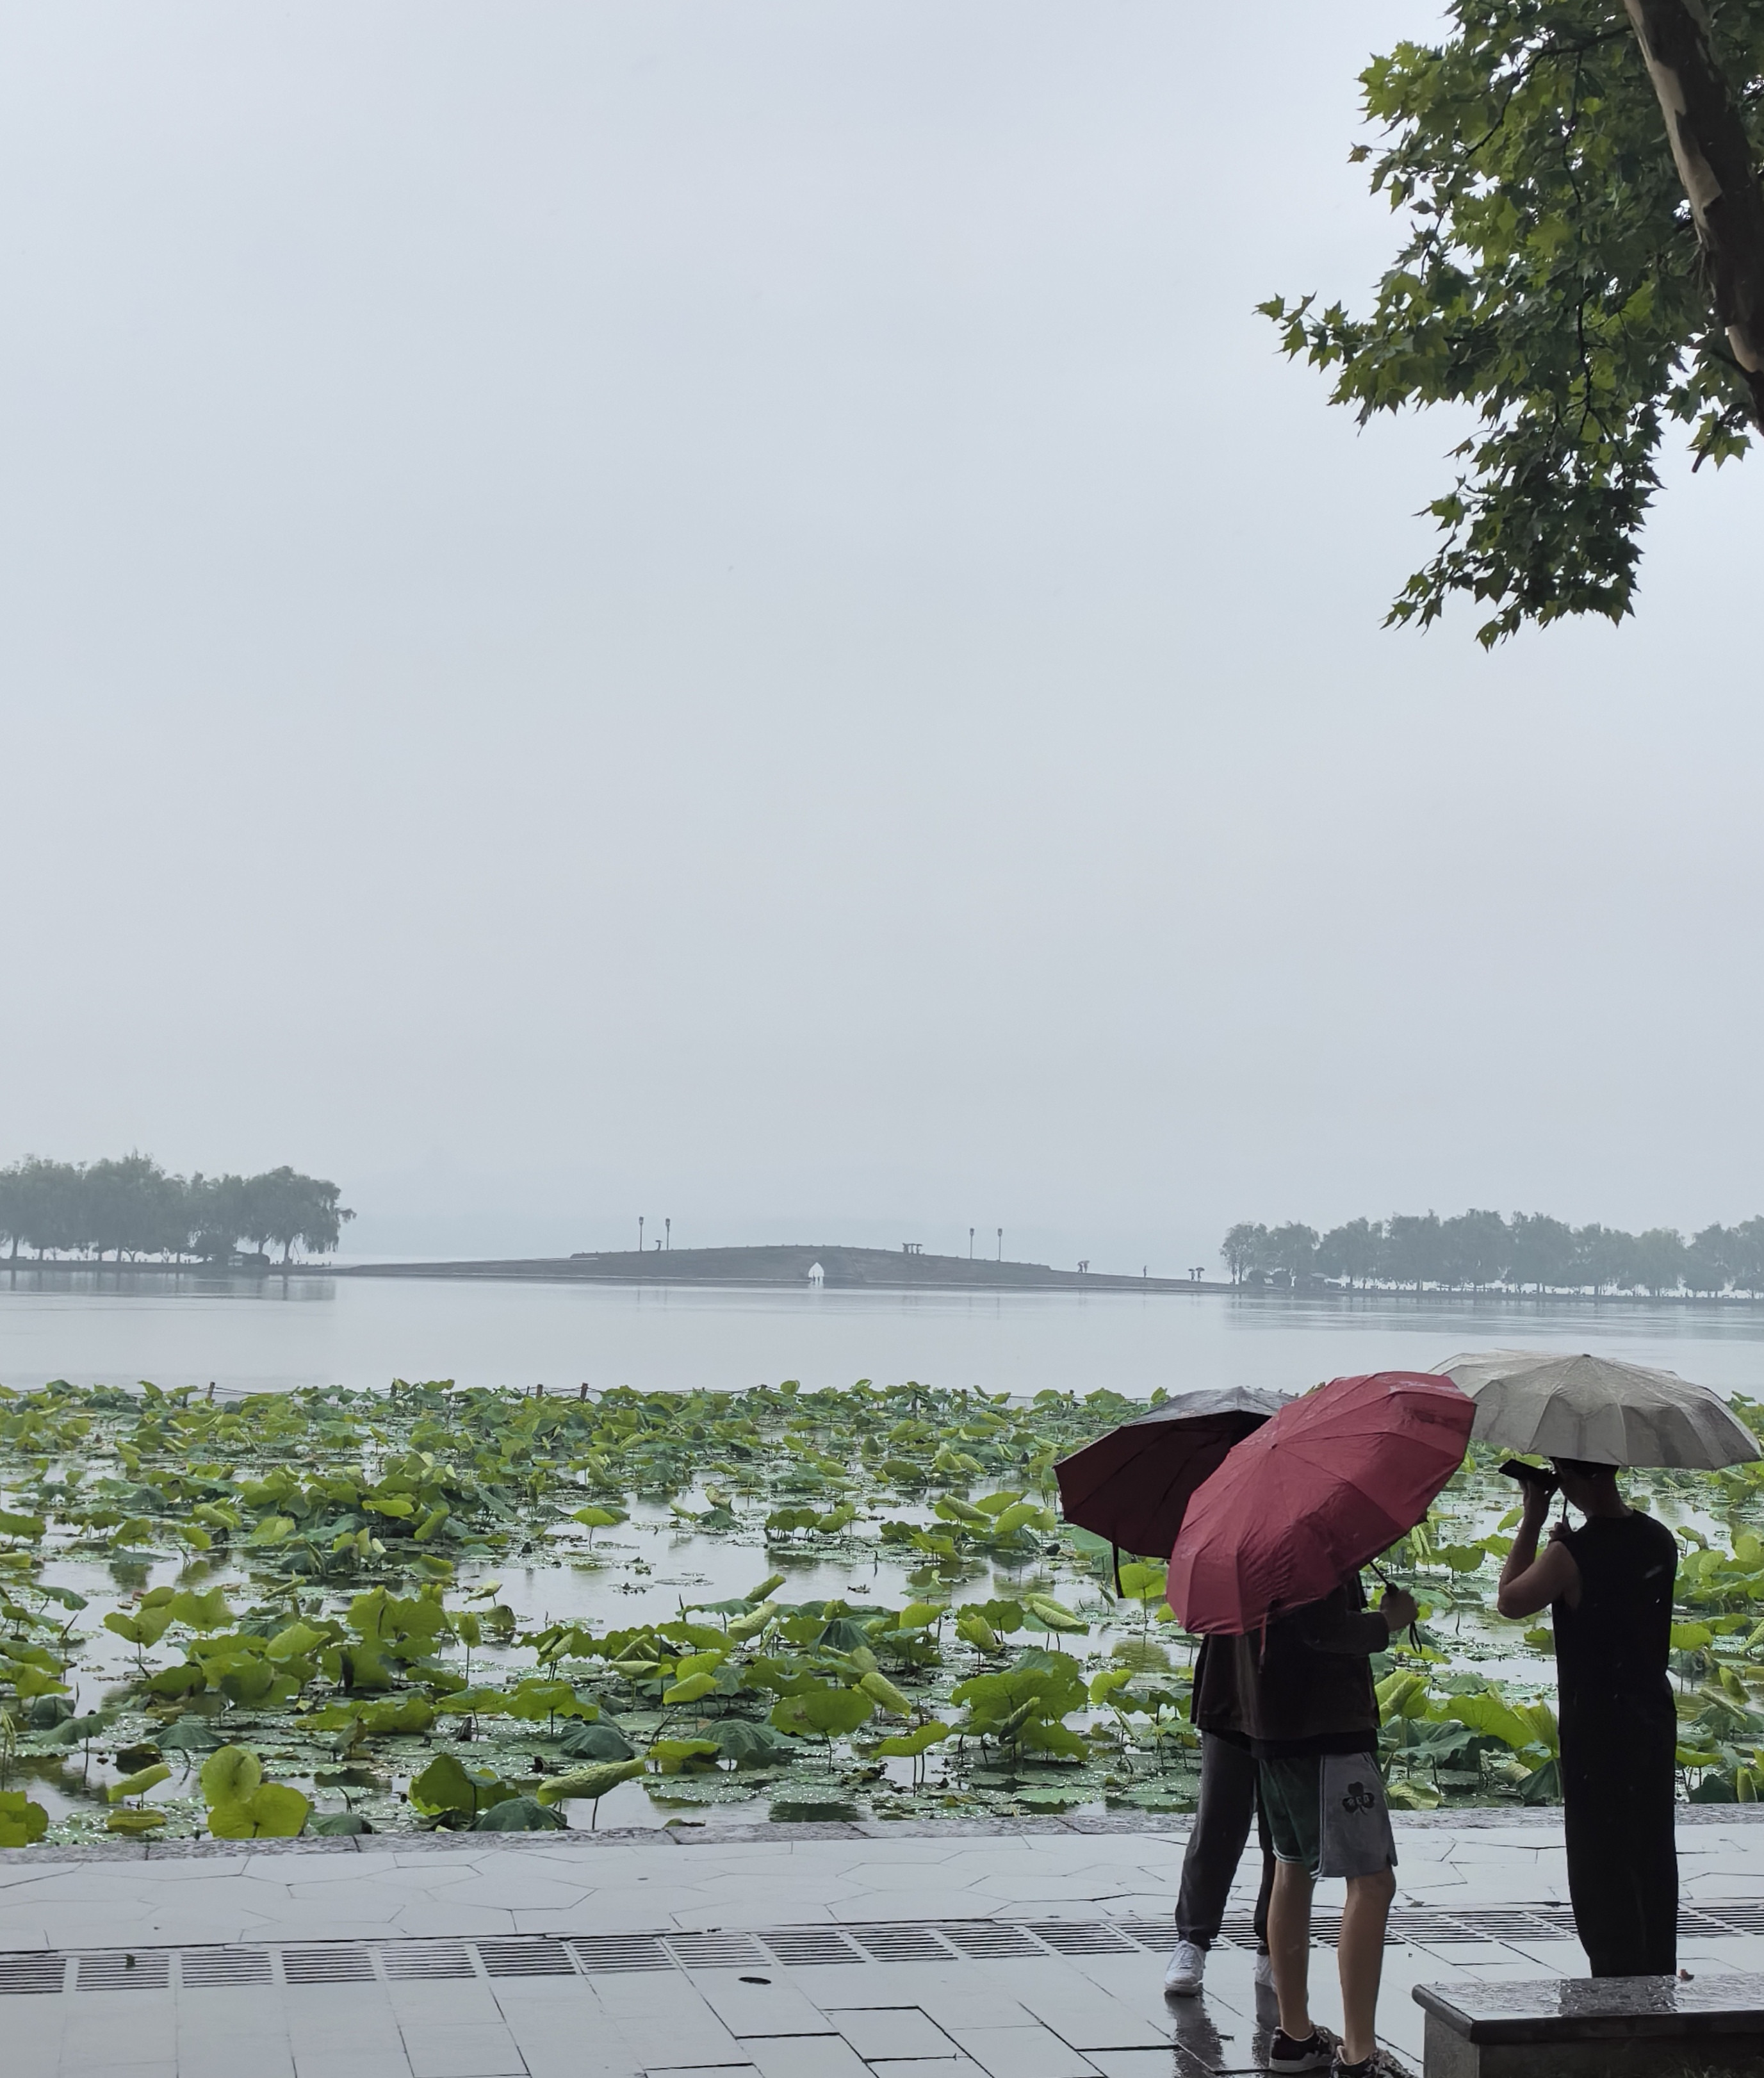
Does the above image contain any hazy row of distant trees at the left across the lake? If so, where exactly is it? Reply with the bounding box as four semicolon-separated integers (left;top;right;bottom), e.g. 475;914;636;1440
0;1156;355;1263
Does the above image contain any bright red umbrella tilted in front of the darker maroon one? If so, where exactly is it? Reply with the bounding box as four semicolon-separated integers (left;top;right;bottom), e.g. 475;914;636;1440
1168;1371;1475;1635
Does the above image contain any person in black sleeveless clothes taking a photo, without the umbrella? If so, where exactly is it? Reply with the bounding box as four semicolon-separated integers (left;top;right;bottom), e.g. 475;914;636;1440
1498;1459;1679;1976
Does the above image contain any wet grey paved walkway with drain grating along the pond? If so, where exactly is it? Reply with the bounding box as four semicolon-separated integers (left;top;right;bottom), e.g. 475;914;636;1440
0;1810;1764;2078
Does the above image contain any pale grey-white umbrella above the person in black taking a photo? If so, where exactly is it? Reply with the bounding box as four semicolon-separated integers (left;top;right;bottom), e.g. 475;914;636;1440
1433;1348;1764;1471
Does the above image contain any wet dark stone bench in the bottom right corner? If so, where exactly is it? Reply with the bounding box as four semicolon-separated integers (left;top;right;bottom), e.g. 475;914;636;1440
1415;1976;1764;2078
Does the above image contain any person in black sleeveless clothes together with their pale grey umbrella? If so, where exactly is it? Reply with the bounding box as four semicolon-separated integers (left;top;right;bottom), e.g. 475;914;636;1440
1440;1351;1760;1976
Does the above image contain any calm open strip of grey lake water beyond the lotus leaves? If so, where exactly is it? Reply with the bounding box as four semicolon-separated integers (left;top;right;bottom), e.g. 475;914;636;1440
0;1268;1764;1398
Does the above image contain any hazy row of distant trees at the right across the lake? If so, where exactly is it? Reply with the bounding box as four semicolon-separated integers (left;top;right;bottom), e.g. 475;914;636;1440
1220;1211;1764;1299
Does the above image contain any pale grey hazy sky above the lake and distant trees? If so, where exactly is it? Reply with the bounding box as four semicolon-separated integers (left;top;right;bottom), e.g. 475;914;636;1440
0;0;1764;1270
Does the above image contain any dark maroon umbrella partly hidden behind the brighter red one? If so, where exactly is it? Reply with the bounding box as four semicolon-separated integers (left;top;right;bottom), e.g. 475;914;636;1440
1054;1386;1286;1558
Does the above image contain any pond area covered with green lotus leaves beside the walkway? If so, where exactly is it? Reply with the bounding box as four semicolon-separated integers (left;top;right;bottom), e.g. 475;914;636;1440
0;1380;1764;1845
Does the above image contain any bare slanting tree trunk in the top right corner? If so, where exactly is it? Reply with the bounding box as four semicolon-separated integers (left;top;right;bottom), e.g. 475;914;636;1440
1622;0;1764;428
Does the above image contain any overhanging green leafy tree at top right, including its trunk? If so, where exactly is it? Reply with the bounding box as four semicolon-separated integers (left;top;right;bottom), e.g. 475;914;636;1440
1261;0;1764;646
